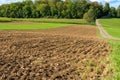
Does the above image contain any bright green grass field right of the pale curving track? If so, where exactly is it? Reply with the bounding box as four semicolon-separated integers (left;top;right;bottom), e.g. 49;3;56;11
100;18;120;38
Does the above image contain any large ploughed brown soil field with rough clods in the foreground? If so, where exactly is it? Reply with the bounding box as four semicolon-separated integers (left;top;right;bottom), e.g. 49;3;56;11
0;26;110;80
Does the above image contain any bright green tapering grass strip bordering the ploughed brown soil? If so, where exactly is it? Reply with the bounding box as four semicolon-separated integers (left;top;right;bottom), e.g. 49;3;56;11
0;22;72;30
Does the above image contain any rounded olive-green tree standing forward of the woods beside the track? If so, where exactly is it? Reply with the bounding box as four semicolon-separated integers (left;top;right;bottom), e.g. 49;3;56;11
83;8;96;23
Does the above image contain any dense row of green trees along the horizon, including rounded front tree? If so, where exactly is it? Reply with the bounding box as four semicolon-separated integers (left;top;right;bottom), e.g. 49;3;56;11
0;0;120;21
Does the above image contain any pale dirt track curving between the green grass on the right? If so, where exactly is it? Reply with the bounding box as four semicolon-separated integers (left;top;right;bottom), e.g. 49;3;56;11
96;19;120;40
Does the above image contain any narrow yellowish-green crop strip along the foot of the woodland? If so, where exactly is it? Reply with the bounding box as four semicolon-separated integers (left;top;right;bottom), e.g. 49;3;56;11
0;17;90;25
